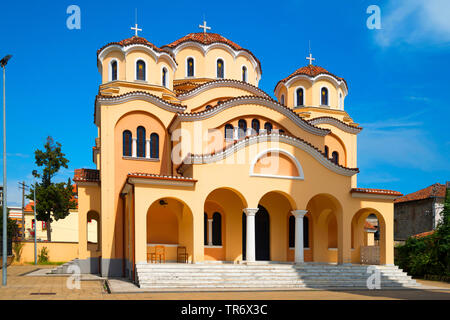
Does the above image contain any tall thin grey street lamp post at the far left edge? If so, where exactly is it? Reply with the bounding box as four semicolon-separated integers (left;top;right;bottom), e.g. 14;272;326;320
0;55;12;286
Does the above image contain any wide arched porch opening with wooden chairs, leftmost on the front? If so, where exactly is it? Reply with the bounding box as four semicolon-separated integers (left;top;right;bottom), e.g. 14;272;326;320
146;197;193;262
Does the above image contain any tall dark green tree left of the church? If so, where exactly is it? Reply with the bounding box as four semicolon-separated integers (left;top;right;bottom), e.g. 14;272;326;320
27;137;76;241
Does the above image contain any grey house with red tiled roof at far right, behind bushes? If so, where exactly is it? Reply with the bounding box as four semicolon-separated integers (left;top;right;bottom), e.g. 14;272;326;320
394;183;446;241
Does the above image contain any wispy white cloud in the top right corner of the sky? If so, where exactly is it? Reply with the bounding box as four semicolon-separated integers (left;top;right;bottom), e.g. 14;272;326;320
375;0;450;47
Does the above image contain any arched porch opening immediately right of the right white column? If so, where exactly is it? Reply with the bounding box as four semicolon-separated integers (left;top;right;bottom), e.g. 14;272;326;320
306;194;342;263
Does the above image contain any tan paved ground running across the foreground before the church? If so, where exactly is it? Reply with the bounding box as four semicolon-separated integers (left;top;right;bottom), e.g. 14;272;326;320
0;265;450;300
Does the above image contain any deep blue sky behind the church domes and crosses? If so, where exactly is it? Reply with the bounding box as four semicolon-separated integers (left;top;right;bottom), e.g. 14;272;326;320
0;0;450;205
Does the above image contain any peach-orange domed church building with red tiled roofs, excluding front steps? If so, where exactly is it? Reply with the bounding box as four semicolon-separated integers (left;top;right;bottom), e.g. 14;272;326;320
74;25;401;278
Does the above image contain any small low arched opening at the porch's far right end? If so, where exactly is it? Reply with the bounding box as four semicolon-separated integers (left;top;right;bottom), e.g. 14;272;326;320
351;208;387;264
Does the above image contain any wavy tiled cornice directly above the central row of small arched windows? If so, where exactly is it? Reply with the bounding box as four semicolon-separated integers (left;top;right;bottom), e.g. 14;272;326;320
169;96;331;136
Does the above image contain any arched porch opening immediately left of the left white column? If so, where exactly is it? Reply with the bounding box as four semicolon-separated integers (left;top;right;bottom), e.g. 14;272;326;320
204;188;247;261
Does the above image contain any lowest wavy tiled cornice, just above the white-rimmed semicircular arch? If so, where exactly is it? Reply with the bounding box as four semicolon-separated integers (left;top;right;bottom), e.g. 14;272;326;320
177;133;359;177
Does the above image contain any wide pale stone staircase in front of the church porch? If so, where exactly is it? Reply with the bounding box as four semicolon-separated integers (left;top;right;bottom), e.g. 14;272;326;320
136;263;420;289
